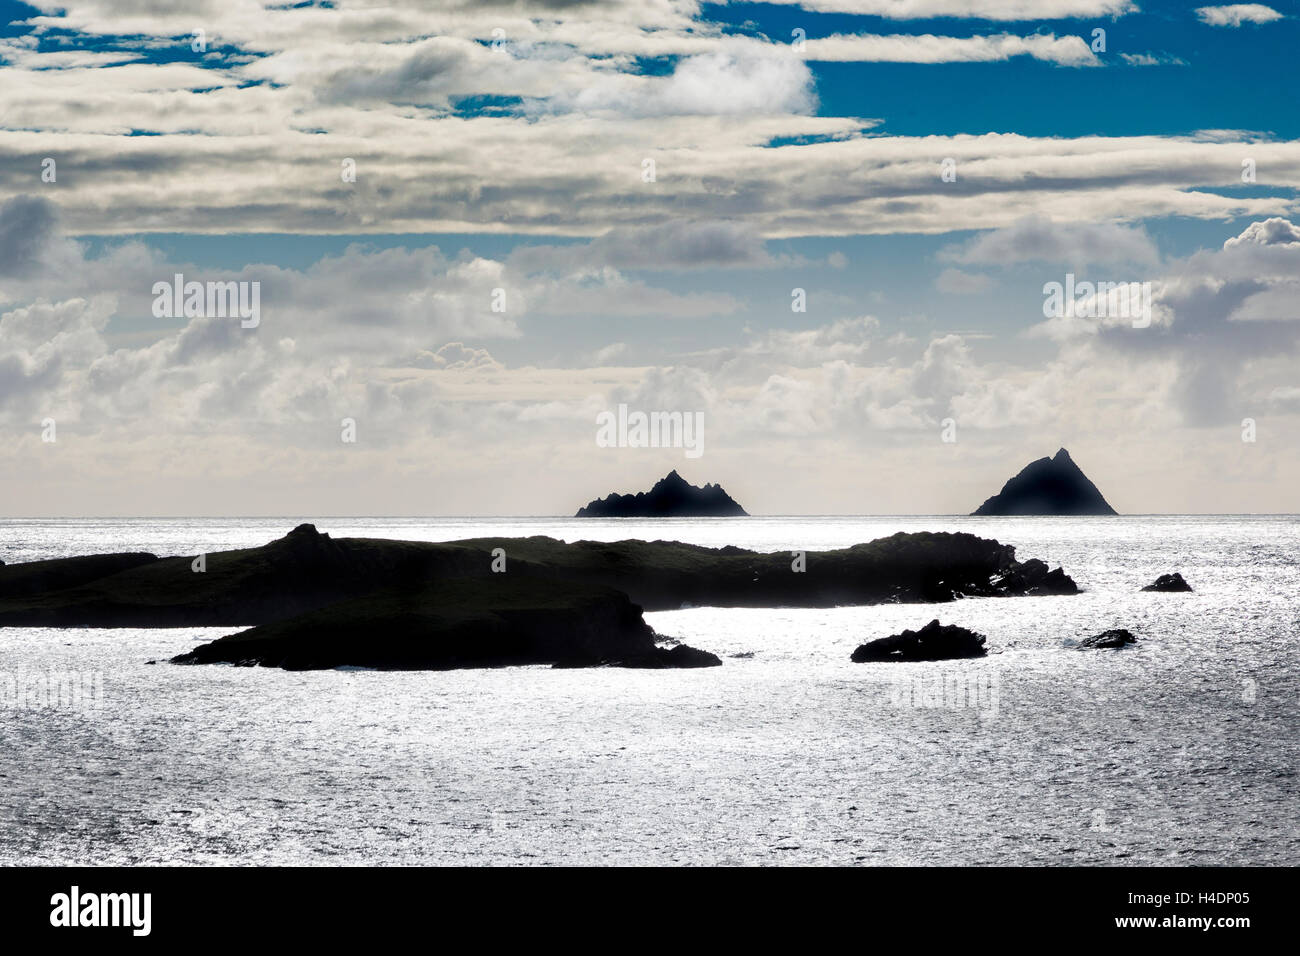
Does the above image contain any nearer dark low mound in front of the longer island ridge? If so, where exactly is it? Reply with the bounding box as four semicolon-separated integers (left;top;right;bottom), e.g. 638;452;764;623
173;574;718;670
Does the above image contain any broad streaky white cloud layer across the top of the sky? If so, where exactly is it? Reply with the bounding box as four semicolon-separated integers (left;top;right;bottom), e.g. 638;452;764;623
0;0;1300;239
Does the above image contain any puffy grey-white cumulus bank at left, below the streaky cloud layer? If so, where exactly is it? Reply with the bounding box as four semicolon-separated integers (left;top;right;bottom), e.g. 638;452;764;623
0;196;759;476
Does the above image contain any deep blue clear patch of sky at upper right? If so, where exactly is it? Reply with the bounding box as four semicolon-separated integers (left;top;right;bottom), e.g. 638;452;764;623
722;0;1300;139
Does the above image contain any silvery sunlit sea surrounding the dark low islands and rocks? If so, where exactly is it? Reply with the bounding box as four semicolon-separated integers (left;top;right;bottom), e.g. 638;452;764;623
0;516;1300;865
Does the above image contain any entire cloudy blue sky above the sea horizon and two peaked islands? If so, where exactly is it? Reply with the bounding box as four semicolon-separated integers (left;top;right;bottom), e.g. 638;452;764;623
0;0;1300;516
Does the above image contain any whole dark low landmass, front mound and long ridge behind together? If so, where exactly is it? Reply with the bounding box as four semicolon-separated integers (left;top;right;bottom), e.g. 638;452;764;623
0;524;1078;669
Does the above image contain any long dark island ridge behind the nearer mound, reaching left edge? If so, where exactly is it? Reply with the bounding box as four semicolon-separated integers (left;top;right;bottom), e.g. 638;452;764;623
0;524;1078;627
